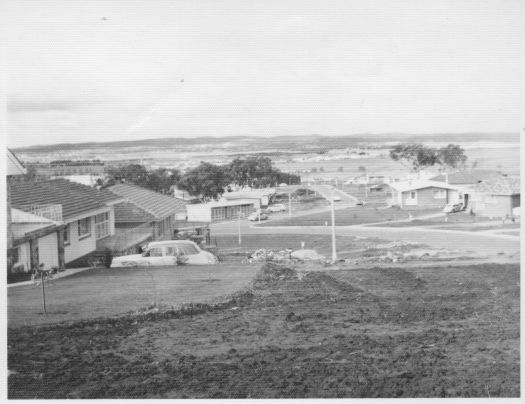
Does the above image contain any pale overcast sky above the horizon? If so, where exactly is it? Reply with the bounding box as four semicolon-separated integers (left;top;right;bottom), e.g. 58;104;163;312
5;0;525;147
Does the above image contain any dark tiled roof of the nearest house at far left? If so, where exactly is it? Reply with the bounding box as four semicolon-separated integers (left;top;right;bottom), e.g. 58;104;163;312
10;178;122;221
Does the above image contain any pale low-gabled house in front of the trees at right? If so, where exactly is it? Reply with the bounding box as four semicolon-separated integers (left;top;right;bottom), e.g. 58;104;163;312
389;180;462;209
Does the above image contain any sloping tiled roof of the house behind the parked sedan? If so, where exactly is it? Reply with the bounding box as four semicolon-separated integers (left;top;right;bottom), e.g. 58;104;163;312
108;184;186;220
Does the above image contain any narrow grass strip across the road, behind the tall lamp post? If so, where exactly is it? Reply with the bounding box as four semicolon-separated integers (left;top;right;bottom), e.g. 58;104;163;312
261;206;439;227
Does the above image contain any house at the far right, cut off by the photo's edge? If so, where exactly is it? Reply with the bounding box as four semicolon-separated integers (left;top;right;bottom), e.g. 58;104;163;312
471;177;521;218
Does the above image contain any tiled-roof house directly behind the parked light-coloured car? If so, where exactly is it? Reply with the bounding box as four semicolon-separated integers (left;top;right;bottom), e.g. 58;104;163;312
107;184;186;243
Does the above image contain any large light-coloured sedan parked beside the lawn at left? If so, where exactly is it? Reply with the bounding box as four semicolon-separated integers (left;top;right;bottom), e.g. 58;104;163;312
111;240;219;268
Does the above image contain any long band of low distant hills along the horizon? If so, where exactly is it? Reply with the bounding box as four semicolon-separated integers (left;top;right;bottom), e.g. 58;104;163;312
13;133;519;153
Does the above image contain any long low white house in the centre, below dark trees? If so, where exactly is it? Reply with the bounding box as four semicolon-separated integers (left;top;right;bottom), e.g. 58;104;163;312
186;199;261;222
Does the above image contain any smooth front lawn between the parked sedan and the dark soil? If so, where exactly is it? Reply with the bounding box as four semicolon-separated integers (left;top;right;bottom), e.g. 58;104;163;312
7;260;257;327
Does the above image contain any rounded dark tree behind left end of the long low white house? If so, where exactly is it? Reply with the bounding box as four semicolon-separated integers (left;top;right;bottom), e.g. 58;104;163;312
177;161;230;201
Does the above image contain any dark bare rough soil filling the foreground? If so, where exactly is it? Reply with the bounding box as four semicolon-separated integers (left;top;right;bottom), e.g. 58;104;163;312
8;264;520;398
